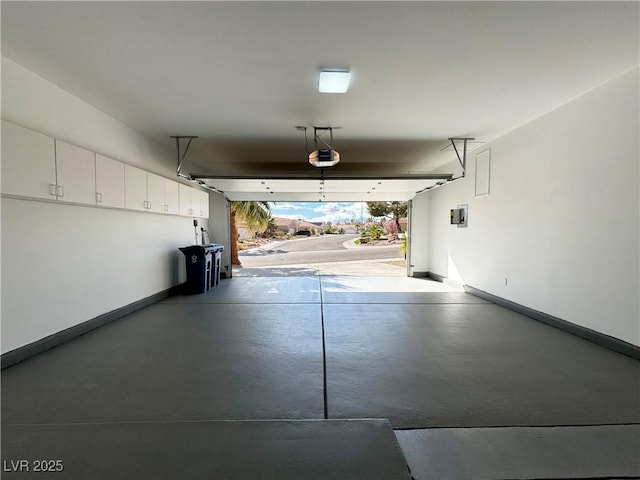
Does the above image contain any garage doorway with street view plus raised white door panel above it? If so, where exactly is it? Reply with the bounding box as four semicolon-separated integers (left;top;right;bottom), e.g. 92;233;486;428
190;171;456;277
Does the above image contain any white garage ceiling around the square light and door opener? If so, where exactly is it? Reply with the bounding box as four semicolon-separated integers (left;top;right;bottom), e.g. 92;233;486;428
1;1;640;199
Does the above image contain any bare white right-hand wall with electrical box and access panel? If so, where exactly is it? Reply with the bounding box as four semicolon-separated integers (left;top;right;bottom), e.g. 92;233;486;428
414;69;640;345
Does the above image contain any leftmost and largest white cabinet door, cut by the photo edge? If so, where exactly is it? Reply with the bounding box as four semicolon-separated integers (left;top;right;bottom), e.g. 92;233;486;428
2;120;56;200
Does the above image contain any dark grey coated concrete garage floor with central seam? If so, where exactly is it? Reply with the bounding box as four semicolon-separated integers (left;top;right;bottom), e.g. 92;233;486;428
2;276;640;479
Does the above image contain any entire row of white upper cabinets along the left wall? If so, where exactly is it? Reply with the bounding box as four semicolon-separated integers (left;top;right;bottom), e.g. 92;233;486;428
2;120;201;218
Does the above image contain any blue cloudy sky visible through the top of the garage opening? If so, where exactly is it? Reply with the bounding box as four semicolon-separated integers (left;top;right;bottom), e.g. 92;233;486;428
271;202;369;224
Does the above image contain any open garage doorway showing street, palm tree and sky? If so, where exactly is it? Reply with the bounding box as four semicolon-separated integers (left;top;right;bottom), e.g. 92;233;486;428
230;201;408;277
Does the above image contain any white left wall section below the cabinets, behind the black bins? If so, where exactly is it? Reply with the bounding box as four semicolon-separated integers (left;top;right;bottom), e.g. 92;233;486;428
2;198;193;353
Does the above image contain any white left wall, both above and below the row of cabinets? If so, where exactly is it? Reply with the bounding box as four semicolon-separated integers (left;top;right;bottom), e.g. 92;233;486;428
1;58;210;353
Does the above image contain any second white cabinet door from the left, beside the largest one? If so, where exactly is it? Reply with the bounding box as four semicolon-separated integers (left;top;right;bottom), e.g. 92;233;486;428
56;140;96;205
